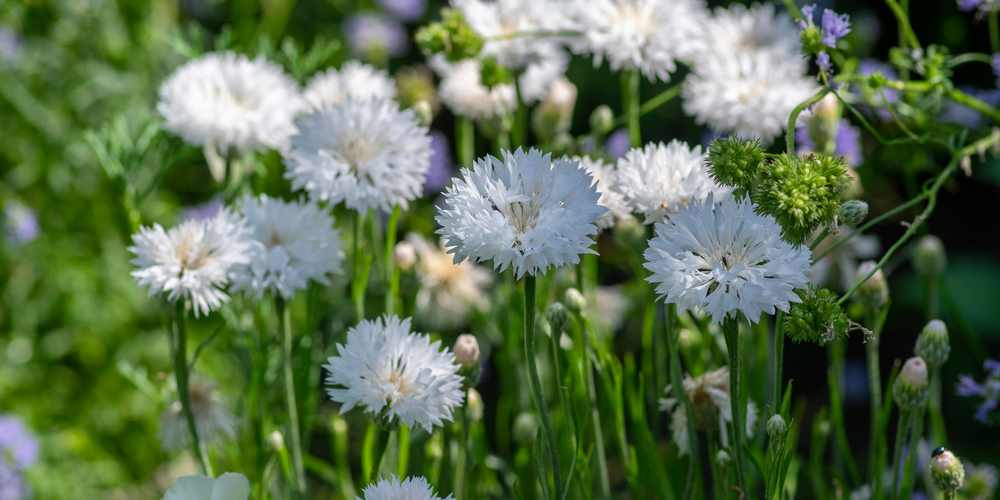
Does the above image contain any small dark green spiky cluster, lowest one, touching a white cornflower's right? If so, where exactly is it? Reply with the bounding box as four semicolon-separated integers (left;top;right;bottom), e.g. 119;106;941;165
782;285;851;345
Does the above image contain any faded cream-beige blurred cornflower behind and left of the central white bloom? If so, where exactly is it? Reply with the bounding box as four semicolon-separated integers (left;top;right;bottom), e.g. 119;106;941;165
406;233;493;330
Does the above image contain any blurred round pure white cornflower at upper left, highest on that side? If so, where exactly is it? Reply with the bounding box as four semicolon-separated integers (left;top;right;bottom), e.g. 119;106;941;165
156;52;303;152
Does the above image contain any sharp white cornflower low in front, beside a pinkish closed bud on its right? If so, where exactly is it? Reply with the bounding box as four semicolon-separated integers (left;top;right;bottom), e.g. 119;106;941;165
323;316;464;432
